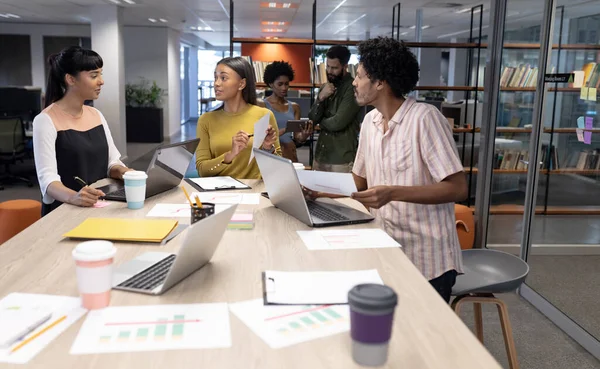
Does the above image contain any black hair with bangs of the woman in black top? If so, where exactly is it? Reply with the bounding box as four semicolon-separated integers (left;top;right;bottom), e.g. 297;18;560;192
45;46;104;107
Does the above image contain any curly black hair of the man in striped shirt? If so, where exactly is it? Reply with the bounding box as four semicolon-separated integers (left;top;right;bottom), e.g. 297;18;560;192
358;37;419;97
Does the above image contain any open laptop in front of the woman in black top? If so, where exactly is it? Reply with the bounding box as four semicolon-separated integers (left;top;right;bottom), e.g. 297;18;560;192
98;138;200;201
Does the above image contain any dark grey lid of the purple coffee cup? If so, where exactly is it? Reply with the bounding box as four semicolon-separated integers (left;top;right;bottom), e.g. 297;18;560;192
348;283;398;311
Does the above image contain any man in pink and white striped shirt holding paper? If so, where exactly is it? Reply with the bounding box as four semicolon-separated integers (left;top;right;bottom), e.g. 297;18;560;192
352;37;467;302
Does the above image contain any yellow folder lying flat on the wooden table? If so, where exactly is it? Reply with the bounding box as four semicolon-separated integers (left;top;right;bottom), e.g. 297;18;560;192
63;218;178;242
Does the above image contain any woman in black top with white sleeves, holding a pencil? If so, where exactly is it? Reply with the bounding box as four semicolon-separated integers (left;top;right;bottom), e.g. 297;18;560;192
33;47;130;215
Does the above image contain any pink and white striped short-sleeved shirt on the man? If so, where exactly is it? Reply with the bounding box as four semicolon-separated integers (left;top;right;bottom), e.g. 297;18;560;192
353;98;463;280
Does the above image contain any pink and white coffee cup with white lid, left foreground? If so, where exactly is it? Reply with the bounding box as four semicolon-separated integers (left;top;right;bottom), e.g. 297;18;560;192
72;241;117;310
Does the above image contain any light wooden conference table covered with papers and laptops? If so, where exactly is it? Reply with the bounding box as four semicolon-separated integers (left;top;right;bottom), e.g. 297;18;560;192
0;181;500;369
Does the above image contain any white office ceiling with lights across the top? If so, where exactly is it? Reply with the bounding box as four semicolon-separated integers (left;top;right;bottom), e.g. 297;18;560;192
0;0;600;46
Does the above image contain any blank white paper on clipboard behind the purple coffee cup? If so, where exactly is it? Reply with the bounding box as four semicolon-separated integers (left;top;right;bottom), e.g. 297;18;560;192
265;269;383;305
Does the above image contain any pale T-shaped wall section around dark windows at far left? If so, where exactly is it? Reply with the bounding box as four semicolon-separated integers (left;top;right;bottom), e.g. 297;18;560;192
0;23;92;91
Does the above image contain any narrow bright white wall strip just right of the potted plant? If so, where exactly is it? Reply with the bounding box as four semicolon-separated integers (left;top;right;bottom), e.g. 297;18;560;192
165;28;181;136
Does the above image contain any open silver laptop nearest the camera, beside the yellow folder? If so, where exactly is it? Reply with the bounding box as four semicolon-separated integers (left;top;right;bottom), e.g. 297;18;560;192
113;205;237;295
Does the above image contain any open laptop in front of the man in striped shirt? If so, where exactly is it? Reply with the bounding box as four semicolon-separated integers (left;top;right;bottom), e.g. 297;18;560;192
253;149;374;227
